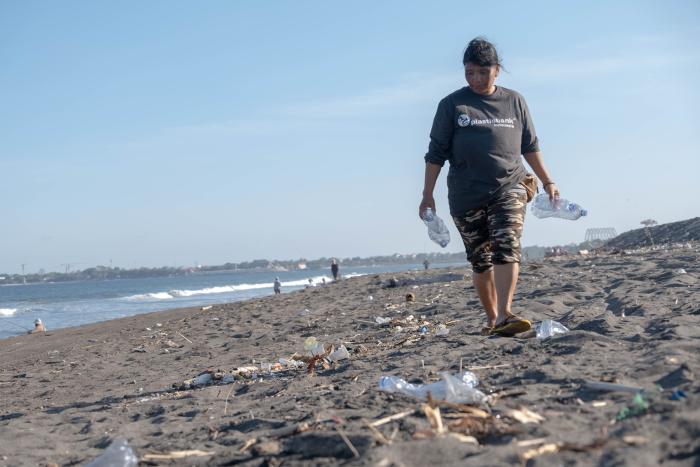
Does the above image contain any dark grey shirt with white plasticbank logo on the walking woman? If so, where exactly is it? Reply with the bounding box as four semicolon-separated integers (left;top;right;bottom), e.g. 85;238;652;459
425;86;539;216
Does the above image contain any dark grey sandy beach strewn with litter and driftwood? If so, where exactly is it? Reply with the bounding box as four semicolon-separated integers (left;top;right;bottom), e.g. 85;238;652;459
0;242;700;466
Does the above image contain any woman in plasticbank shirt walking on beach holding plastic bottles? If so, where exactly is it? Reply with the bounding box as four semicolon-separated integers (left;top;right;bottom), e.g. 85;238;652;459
418;37;559;336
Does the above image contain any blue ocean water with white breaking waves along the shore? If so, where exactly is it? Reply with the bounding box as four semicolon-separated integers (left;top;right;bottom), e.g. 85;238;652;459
0;264;465;339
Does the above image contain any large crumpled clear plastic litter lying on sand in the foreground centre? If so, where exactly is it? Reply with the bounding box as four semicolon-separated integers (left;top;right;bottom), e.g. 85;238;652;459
379;371;486;404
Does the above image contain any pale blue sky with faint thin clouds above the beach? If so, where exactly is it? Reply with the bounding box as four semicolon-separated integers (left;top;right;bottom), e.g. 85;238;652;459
0;0;700;273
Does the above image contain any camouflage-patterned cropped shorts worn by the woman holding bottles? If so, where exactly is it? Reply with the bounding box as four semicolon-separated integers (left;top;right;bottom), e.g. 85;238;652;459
452;186;527;272
